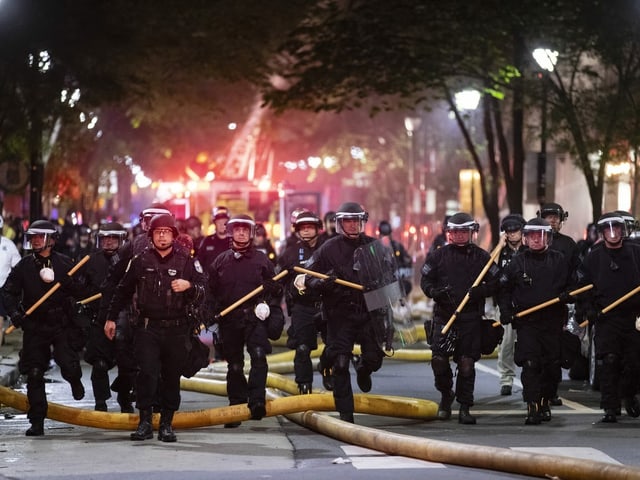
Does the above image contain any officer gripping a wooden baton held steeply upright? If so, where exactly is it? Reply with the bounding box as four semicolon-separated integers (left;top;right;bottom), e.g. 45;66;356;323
420;212;498;425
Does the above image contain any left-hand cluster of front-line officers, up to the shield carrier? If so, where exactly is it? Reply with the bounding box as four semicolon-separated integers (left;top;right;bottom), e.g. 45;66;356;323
0;202;416;442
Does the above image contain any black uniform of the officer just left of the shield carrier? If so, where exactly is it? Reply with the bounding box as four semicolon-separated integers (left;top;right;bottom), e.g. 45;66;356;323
278;240;326;393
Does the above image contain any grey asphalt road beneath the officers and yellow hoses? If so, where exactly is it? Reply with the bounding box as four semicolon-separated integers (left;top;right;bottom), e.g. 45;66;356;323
0;334;640;480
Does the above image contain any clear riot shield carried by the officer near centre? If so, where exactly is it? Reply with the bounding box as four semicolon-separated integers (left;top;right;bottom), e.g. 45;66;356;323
354;240;417;350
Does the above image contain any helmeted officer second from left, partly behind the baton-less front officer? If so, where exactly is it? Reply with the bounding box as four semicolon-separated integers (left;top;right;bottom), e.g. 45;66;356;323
76;222;135;413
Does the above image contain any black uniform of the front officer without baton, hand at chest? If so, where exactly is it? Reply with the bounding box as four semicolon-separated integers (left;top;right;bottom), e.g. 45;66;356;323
107;247;206;412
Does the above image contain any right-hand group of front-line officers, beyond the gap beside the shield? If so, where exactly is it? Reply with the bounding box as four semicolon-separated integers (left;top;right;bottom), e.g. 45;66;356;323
421;203;640;425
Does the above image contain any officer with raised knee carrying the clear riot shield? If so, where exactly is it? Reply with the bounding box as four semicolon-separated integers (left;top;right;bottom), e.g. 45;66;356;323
304;202;384;423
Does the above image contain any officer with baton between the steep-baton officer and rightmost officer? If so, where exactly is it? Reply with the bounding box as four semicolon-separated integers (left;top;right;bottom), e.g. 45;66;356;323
498;218;573;425
